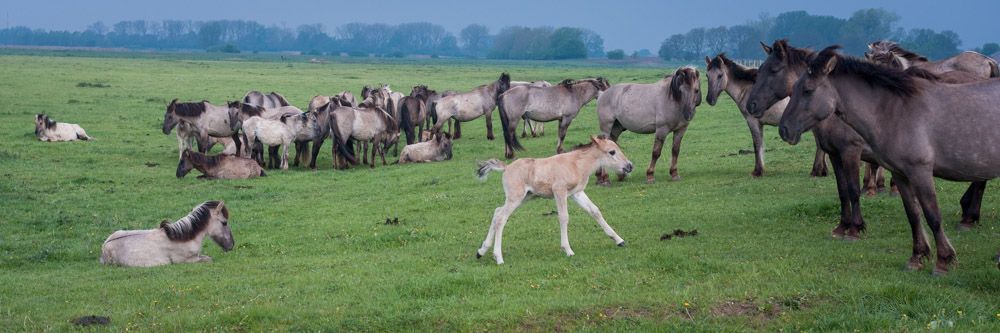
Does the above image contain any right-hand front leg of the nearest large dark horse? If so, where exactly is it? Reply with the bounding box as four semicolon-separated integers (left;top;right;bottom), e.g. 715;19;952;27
907;169;955;274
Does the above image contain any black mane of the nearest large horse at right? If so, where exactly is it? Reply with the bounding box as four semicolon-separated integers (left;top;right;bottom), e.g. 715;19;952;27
809;45;937;97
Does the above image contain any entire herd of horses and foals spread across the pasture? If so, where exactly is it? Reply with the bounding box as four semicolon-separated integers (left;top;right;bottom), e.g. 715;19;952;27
29;40;1000;274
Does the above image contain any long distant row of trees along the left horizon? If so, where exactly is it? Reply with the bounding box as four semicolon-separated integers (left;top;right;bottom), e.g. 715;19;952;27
0;20;604;59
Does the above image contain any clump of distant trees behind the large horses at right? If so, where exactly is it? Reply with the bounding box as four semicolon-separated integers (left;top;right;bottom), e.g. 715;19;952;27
659;9;996;60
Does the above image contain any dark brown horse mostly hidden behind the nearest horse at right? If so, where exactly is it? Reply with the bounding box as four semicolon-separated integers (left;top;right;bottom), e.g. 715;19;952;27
747;40;877;239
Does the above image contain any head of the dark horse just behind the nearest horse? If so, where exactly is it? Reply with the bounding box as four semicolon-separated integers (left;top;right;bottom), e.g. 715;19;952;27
747;40;811;117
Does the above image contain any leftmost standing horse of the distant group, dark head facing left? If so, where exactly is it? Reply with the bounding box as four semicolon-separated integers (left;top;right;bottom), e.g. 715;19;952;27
163;98;242;157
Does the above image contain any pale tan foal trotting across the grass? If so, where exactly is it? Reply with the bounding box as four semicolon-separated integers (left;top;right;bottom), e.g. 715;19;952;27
476;136;632;264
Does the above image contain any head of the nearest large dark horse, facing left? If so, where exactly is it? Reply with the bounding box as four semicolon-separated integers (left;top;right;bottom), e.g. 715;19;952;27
778;46;840;145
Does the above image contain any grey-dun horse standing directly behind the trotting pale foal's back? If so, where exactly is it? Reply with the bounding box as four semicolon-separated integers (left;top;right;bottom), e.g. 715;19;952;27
499;77;609;158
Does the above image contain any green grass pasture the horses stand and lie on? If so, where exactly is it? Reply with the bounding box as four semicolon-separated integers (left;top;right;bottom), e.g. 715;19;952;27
0;50;1000;332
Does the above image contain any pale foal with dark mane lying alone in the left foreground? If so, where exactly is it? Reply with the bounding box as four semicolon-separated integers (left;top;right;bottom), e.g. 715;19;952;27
101;201;234;267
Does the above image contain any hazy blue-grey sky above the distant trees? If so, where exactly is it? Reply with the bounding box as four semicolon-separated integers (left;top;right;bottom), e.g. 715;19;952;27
0;0;1000;53
